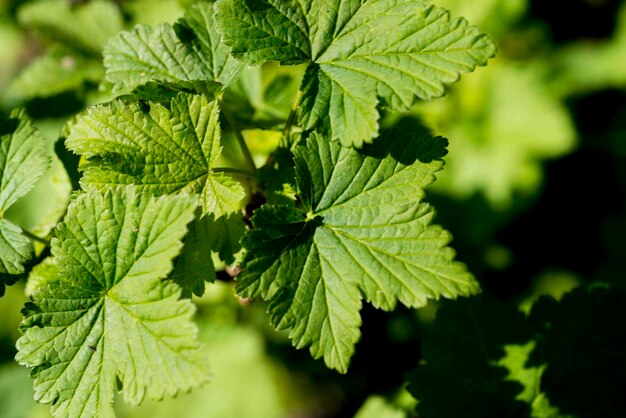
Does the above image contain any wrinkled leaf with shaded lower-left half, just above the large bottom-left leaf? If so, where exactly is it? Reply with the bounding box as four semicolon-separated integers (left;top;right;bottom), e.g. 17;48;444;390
66;93;245;218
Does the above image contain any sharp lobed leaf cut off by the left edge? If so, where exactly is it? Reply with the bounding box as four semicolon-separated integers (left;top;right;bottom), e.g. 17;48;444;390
0;110;50;276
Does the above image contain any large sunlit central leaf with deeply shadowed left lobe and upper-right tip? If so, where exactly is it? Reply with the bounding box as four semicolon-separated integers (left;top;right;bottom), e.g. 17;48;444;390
237;132;478;372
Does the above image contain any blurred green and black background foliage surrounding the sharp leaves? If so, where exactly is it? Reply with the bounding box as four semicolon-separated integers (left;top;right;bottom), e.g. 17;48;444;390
0;0;626;418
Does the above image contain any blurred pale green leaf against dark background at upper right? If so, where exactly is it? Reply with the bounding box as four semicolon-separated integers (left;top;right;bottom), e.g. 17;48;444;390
416;59;576;208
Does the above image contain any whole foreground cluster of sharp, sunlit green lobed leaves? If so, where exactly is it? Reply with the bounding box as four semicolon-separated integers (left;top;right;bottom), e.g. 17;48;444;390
0;0;508;417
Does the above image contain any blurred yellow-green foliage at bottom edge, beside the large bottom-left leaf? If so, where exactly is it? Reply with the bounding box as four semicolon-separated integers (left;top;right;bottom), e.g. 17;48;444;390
114;298;292;418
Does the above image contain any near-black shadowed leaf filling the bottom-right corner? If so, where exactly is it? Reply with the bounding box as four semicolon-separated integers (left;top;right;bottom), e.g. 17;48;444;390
529;288;626;418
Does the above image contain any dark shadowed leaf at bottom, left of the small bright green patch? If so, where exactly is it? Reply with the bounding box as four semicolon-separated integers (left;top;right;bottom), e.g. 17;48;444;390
409;296;532;418
